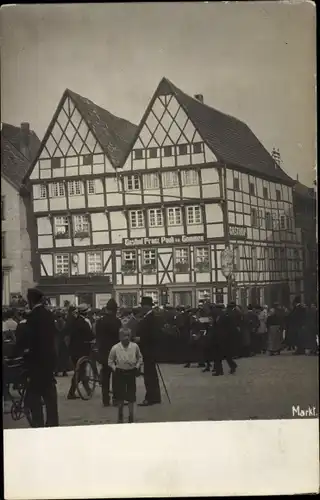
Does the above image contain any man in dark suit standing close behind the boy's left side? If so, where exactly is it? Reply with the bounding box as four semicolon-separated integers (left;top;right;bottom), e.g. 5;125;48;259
96;299;121;406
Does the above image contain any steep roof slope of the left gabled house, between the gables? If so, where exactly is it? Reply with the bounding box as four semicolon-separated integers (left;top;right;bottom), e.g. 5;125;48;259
66;89;137;167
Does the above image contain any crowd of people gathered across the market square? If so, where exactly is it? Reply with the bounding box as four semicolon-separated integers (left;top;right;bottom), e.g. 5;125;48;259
2;289;318;427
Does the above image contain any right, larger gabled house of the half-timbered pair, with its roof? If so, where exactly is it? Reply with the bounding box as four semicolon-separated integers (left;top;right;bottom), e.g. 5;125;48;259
114;79;303;305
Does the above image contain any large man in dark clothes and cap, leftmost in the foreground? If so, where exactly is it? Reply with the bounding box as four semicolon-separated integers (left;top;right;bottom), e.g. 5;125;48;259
16;288;59;427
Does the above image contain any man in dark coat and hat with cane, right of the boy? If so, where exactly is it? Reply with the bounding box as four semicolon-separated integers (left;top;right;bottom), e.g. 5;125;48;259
136;297;161;406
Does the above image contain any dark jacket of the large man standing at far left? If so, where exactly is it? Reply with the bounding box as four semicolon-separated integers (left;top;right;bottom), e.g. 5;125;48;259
16;305;57;383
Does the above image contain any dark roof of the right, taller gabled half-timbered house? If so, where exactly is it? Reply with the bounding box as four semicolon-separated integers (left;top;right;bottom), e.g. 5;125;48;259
124;78;293;184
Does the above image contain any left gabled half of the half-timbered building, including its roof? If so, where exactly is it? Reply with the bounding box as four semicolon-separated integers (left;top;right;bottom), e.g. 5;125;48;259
25;90;136;307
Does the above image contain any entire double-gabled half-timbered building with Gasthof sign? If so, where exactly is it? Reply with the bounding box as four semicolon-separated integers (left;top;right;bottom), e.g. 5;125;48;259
27;78;303;307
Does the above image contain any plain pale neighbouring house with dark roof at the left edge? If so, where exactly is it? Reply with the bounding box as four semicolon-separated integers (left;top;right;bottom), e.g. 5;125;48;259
1;123;40;305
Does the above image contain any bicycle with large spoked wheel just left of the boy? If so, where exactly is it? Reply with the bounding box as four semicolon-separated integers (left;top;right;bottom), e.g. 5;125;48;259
74;340;101;401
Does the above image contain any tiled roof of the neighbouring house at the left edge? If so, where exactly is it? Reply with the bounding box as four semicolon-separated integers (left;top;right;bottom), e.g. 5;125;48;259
1;123;40;190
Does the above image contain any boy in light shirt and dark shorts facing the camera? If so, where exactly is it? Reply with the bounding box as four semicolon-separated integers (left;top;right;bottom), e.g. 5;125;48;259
108;327;142;423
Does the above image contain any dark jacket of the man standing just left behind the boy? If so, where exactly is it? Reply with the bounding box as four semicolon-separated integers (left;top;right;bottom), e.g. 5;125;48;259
96;314;121;364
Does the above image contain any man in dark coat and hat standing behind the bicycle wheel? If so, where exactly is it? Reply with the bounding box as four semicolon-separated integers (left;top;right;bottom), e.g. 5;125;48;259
68;304;94;399
